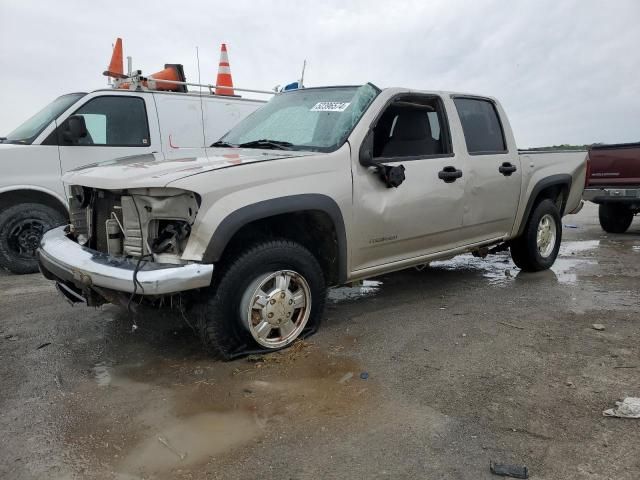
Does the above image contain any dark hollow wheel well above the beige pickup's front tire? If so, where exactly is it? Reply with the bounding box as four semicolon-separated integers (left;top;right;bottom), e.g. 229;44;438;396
220;210;340;285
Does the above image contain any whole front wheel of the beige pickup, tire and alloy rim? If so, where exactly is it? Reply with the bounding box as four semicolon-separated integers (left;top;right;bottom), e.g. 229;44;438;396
199;240;326;360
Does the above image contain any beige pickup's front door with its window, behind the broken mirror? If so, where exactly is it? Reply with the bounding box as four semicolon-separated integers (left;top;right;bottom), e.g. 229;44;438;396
351;94;467;276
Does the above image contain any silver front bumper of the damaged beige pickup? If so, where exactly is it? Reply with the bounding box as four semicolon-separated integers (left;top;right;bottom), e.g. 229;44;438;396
38;227;213;295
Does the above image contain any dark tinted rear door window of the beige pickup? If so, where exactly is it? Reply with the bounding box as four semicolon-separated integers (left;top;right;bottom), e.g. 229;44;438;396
454;98;507;154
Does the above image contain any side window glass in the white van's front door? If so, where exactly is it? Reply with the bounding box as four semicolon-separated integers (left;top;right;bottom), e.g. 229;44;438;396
74;96;150;147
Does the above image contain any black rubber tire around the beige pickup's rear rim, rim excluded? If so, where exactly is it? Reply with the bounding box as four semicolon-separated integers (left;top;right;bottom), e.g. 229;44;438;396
510;199;562;272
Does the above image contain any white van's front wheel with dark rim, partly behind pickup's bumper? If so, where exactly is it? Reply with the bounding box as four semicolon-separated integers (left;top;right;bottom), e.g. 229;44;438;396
0;203;66;274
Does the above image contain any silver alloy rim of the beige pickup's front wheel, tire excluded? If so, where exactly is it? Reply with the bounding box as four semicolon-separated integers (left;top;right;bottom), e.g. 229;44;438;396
240;270;311;348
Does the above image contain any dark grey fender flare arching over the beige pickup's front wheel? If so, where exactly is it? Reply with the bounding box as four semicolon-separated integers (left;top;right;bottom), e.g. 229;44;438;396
202;193;347;283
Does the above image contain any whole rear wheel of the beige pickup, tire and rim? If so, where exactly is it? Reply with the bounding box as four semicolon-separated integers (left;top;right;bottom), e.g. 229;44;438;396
511;199;562;272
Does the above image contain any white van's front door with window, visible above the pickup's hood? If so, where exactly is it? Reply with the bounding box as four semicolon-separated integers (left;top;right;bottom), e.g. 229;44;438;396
57;92;160;172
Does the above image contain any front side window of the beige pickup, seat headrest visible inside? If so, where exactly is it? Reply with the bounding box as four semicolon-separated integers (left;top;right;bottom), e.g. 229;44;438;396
373;97;451;158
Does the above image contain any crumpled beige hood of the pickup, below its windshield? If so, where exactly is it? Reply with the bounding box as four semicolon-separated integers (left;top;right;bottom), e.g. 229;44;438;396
62;148;315;190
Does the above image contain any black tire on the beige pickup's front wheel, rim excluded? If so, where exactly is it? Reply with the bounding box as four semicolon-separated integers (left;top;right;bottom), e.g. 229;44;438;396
198;240;327;360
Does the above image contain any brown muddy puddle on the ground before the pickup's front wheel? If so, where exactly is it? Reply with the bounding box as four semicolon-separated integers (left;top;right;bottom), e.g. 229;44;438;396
64;344;375;479
